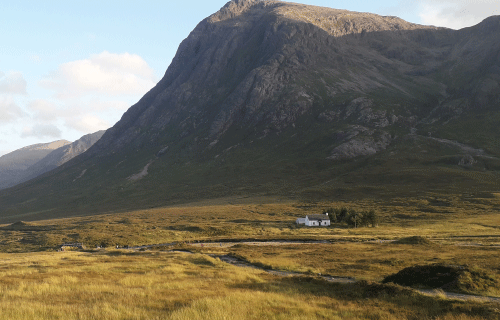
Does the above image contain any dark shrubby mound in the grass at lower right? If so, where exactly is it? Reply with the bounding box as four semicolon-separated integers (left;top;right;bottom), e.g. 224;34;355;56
382;264;500;294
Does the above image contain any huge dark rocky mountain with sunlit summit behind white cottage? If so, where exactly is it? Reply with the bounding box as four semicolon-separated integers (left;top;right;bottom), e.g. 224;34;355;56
0;0;500;221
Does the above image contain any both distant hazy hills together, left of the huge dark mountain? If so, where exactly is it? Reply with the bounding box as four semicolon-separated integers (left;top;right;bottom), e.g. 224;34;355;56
0;130;105;189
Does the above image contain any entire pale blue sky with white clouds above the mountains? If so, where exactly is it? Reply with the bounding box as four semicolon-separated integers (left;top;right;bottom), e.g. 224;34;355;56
0;0;500;156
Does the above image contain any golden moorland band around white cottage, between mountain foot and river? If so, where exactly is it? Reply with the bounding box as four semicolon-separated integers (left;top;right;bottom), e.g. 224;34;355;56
0;194;500;252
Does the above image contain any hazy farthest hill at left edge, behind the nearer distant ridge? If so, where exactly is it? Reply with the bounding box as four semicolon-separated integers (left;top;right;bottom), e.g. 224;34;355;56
0;140;70;189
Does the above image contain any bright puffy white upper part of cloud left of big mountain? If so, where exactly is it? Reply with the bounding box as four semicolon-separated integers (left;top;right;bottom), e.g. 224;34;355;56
40;51;156;98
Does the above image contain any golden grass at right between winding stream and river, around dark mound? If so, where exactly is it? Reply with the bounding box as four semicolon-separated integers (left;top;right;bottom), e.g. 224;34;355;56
224;243;500;296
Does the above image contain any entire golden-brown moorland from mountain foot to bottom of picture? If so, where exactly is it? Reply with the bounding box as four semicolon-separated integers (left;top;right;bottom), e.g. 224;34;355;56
0;194;500;320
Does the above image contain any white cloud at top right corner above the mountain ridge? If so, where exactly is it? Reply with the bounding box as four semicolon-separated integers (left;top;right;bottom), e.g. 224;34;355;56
418;0;500;29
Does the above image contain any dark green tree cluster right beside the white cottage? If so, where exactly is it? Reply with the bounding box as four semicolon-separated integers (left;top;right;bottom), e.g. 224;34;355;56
323;207;378;228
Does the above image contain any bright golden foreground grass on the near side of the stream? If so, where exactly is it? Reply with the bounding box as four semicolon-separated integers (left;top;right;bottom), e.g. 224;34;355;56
0;250;498;320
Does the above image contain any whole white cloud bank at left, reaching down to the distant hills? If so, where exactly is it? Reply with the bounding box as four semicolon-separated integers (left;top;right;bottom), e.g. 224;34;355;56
0;51;156;150
